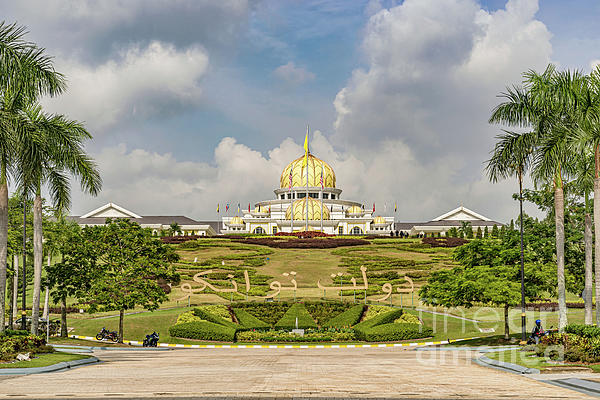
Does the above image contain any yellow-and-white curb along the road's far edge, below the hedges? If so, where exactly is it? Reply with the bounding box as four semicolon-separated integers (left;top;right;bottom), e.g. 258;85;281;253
70;335;478;349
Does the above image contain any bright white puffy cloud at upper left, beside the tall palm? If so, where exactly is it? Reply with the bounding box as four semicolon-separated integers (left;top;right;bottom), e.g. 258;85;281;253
47;42;209;131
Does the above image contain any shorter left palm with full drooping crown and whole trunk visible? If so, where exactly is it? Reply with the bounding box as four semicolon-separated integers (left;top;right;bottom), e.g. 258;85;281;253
15;105;102;334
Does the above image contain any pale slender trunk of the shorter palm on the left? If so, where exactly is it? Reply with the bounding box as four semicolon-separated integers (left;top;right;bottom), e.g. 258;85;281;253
31;189;43;335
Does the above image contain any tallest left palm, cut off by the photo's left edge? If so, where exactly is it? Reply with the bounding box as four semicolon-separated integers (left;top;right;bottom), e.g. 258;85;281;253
0;22;64;332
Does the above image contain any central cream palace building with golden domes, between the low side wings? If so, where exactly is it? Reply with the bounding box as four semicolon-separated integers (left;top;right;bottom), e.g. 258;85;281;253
221;153;395;236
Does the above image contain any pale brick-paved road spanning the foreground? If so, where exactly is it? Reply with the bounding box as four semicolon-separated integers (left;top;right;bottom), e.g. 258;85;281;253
0;348;586;399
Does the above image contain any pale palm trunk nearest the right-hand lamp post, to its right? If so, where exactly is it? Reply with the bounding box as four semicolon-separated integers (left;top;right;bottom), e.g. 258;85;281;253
554;184;567;332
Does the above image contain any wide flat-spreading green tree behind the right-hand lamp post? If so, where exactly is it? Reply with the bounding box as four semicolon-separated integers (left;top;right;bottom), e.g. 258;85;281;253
419;264;554;339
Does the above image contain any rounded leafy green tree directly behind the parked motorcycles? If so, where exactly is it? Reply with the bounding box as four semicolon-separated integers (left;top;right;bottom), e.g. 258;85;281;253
85;219;179;342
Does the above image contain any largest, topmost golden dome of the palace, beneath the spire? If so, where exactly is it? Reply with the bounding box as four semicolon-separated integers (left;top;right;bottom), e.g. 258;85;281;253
279;153;335;190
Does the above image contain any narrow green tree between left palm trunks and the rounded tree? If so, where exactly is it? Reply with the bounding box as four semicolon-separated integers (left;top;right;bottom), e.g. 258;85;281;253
46;220;99;337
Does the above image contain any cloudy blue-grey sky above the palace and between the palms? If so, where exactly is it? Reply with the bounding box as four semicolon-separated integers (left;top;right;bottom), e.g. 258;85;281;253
0;0;600;221
